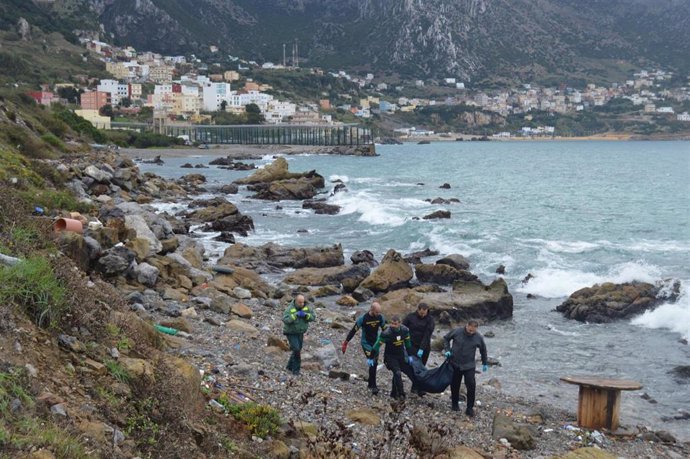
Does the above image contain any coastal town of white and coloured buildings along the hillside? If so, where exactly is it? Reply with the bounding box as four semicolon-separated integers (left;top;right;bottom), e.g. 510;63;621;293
24;39;690;140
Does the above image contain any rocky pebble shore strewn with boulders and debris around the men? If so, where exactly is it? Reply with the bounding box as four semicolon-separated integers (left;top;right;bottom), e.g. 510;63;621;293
18;147;690;459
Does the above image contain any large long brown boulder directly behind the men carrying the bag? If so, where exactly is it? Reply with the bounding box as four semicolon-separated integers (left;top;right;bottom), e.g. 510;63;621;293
380;279;513;323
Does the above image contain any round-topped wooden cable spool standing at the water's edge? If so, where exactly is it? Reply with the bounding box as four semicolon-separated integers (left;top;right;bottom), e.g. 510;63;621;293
561;376;642;430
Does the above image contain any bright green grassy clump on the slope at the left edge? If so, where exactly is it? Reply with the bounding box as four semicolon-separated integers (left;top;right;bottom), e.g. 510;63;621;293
0;257;67;327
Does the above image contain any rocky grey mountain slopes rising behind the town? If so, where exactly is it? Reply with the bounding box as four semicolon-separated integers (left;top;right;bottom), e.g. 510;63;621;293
6;0;690;80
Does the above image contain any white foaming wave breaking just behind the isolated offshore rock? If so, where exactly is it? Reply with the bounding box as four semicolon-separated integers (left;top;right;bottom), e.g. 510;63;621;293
517;262;661;298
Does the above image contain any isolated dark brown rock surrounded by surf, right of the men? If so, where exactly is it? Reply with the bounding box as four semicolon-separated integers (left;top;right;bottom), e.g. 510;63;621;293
556;282;680;323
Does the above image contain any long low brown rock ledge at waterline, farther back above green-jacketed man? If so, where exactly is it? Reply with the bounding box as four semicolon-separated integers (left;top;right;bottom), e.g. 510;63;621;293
219;242;345;274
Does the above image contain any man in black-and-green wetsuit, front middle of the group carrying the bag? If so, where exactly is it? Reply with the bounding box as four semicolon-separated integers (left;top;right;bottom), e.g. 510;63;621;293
374;316;414;399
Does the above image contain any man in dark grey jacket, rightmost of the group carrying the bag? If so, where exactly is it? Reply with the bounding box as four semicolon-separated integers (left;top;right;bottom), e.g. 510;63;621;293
443;320;489;417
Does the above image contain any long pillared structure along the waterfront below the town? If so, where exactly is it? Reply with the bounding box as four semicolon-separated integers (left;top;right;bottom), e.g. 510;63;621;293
112;122;373;146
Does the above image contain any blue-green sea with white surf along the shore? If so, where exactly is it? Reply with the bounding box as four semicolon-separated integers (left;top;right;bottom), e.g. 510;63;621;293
140;141;690;441
